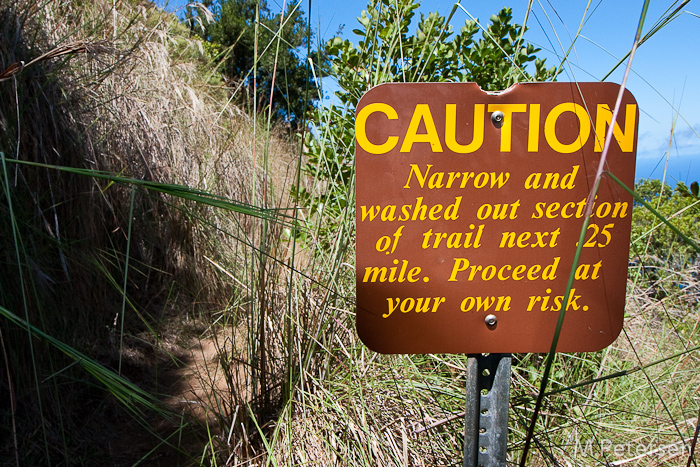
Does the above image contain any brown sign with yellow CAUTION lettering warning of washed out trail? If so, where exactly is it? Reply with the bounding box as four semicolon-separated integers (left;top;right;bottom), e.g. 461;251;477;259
355;83;639;353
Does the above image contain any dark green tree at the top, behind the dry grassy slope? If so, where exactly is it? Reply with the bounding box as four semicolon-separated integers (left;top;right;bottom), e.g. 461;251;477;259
187;0;316;128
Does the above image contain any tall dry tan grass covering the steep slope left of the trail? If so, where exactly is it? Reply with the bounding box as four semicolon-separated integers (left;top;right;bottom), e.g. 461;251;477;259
0;0;292;465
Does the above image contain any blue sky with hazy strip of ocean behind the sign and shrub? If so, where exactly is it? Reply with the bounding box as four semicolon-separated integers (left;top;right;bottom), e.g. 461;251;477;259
160;0;700;184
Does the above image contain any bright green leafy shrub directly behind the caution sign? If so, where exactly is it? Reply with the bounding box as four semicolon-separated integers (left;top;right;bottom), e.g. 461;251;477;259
296;0;555;245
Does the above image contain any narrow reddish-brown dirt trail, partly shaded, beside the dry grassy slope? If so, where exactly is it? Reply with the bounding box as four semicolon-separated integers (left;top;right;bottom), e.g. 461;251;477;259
110;329;248;467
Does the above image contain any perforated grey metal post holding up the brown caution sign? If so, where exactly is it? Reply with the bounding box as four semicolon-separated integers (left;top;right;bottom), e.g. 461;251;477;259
462;354;511;467
